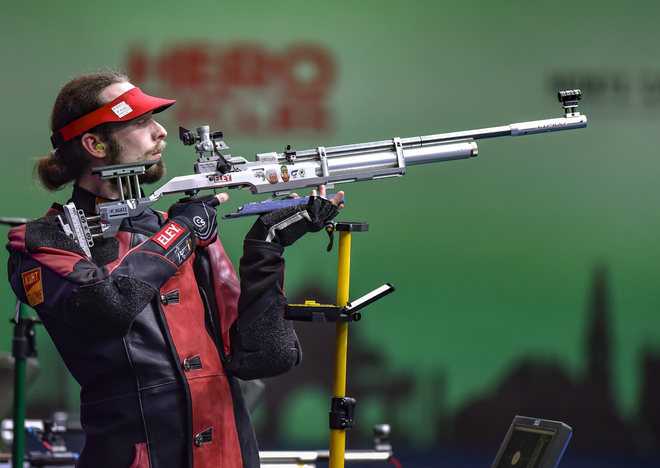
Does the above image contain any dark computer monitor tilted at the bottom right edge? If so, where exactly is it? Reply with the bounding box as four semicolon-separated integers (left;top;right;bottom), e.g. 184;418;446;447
491;416;573;468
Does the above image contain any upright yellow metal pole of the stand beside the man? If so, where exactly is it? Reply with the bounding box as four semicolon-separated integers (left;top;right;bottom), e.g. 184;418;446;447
329;231;351;468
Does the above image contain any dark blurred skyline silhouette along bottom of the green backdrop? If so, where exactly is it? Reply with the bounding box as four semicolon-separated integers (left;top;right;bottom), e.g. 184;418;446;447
259;266;660;453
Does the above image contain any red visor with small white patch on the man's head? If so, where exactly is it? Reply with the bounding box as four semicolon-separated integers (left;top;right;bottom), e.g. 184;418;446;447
50;88;176;148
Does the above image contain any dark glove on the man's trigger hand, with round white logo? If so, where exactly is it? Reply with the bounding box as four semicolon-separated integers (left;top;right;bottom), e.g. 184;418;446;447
167;195;220;247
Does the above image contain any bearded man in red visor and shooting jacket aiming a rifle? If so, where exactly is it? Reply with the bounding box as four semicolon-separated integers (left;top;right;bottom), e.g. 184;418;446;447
8;72;343;468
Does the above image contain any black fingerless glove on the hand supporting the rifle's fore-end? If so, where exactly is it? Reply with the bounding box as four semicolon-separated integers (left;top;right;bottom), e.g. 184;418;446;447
245;197;339;247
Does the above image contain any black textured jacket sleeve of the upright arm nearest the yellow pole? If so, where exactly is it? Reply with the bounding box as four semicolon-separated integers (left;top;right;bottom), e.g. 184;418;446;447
227;239;302;380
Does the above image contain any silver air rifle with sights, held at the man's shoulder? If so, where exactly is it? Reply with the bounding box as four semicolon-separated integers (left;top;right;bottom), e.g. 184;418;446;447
60;89;587;257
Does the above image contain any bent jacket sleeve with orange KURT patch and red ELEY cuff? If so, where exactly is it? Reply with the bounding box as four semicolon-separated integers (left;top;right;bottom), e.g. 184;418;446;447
7;216;194;335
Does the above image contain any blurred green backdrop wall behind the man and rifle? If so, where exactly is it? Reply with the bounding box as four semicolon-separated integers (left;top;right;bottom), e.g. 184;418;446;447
0;0;660;452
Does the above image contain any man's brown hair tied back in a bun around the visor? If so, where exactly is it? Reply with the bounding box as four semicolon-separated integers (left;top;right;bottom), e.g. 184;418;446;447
34;71;128;191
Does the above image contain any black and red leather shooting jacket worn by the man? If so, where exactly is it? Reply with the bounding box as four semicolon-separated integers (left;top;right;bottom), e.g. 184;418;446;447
8;187;300;468
